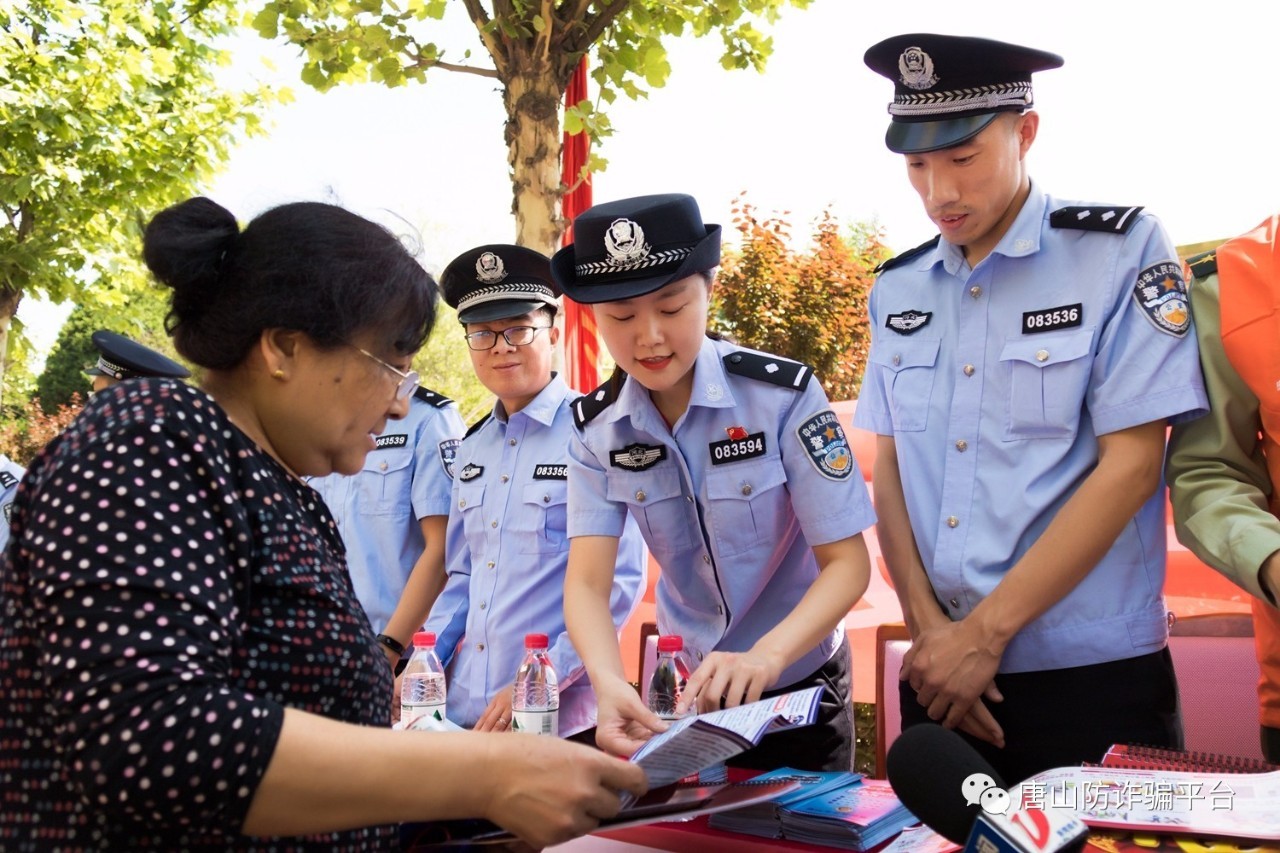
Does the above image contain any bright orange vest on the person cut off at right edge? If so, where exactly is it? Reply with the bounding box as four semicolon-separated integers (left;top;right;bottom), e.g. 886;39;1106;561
1217;215;1280;727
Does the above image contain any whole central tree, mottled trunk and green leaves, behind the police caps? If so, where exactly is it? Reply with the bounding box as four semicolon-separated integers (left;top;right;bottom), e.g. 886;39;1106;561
252;0;812;254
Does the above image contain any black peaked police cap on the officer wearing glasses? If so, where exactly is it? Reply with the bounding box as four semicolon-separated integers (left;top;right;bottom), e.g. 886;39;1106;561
440;243;559;323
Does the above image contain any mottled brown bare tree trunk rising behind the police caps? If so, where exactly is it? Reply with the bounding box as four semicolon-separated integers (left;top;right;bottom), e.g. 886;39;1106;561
503;68;564;255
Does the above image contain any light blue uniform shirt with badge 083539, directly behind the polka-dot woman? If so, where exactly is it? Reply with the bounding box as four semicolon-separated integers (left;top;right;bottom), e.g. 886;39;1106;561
310;394;465;633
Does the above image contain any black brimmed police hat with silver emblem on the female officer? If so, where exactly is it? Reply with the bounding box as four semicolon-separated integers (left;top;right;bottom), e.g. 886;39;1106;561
552;193;721;304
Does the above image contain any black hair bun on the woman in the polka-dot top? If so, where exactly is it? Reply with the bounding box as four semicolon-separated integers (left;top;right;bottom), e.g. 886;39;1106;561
142;196;239;300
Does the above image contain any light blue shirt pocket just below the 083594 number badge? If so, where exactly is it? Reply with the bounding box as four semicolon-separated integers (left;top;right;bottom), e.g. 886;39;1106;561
707;457;791;557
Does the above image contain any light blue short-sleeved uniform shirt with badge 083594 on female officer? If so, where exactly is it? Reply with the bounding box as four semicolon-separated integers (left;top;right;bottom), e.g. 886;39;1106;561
568;338;876;686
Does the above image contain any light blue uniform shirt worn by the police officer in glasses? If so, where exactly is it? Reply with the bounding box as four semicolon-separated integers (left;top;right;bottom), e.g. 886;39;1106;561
426;377;648;736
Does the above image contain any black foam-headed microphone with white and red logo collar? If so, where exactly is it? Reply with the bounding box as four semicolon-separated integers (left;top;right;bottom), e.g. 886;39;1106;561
886;724;1089;853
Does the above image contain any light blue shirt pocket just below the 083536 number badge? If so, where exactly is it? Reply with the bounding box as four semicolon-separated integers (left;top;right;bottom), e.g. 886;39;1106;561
1000;327;1093;441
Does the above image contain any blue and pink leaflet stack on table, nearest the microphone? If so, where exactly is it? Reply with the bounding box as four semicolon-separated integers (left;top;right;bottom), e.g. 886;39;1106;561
780;779;919;850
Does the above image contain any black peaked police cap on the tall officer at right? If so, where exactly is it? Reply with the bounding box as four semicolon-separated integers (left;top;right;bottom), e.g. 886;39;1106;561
863;33;1062;154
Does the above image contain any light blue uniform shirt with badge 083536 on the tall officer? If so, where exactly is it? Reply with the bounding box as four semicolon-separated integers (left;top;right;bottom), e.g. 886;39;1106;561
854;183;1207;672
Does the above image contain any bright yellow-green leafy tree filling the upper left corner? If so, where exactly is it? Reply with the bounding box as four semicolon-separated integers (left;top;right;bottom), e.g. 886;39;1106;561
0;0;279;384
